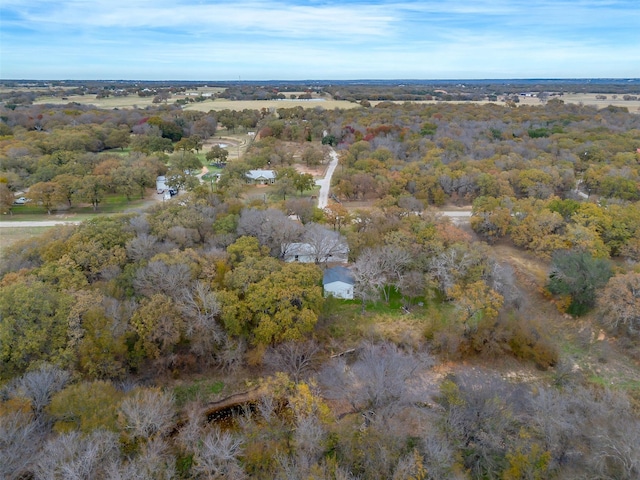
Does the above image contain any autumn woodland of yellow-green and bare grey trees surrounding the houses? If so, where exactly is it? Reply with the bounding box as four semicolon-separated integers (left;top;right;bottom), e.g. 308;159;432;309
0;86;640;480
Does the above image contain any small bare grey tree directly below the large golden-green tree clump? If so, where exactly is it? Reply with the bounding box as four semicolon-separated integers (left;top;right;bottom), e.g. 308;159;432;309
264;340;320;383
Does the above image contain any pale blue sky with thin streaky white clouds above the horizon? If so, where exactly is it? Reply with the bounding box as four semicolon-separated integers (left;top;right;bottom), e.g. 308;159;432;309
0;0;640;80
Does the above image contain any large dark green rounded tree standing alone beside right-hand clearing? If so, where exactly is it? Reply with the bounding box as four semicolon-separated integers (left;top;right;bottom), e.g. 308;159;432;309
547;250;613;315
